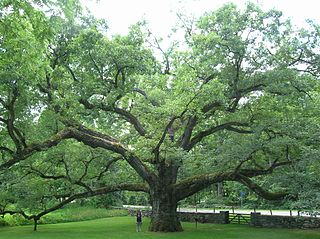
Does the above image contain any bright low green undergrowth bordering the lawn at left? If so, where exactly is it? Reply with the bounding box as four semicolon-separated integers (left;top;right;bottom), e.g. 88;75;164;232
0;207;128;226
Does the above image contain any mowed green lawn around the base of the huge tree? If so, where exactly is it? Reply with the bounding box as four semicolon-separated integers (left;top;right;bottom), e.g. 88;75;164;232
0;217;320;239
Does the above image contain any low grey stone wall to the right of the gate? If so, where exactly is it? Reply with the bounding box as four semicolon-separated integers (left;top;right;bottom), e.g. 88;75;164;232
250;213;320;229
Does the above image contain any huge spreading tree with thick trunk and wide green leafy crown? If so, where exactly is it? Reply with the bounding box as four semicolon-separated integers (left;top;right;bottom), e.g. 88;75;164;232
0;0;320;231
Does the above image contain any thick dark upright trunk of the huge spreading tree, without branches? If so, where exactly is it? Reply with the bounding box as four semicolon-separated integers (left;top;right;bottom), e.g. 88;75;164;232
149;162;182;232
